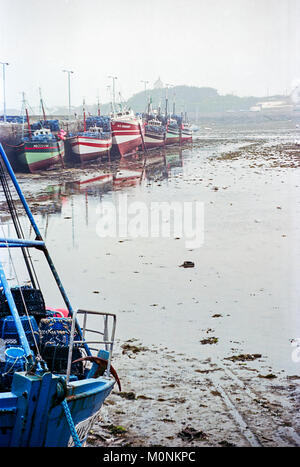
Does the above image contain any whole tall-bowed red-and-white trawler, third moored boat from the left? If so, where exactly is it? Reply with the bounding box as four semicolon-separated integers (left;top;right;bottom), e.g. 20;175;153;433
111;110;142;157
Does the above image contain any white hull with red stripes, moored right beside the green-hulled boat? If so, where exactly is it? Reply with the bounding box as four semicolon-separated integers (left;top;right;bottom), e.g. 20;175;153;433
70;135;112;162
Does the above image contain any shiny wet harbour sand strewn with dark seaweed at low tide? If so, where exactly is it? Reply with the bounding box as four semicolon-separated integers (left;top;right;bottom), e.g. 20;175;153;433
0;124;300;446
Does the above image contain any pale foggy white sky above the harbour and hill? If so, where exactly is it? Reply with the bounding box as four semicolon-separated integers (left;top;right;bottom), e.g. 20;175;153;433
0;0;300;113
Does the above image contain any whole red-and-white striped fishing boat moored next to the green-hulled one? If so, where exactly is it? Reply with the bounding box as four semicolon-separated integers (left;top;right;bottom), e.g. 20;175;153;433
68;100;112;162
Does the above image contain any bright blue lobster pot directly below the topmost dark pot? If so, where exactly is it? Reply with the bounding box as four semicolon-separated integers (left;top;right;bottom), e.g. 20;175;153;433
0;316;40;348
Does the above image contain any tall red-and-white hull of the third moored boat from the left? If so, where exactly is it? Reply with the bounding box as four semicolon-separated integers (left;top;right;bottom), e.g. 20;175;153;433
111;119;142;157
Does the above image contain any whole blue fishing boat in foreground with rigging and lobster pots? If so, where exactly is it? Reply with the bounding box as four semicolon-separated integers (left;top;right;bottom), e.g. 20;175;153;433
0;144;121;447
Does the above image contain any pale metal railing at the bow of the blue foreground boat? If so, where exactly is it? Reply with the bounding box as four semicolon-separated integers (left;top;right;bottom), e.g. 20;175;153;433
66;310;116;384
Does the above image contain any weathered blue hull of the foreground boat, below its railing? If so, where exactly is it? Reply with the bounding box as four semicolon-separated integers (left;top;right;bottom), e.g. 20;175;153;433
0;372;115;447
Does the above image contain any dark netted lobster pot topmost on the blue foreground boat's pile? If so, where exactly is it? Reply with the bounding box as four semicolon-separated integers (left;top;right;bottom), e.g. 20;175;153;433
0;285;47;324
